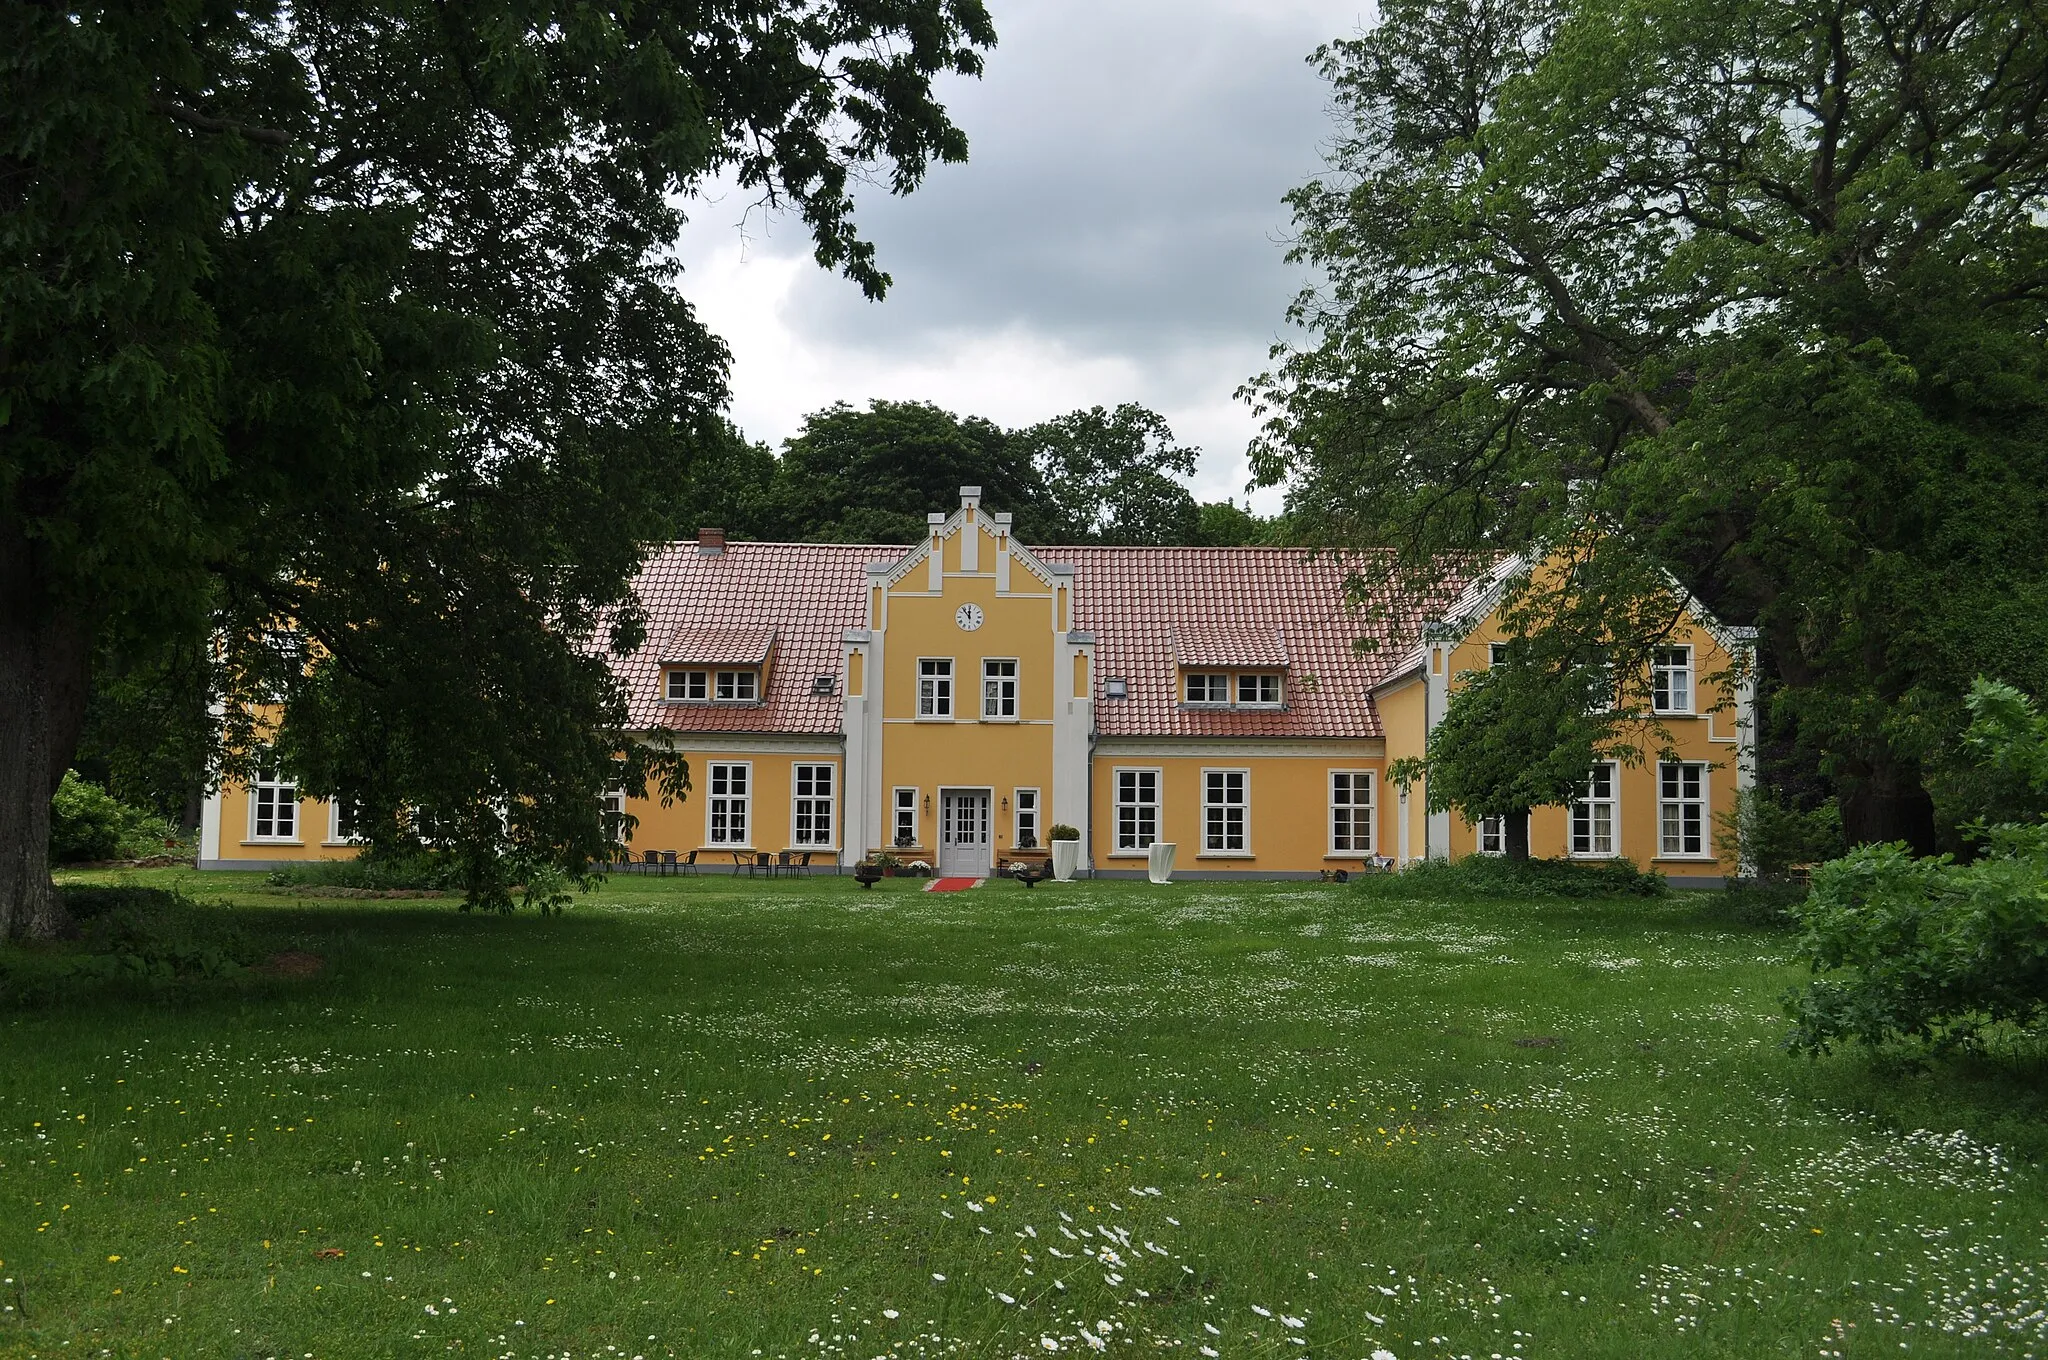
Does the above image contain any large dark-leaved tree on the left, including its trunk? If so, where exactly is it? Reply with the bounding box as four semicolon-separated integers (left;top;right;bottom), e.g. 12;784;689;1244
0;0;993;938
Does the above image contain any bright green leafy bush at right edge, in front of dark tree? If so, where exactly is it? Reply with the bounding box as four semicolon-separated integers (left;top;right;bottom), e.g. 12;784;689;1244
1786;825;2048;1053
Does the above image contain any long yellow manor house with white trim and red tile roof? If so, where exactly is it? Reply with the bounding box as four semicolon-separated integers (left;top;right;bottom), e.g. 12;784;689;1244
199;487;1753;885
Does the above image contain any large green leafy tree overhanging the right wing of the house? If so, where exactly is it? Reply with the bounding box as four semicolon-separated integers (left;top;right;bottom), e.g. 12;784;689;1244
1251;0;2048;850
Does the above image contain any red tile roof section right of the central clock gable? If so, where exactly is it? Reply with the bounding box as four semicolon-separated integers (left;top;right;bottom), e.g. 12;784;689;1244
1032;547;1464;737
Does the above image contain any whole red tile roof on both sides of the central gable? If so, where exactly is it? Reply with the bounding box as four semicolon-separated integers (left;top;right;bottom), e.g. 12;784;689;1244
614;541;1464;737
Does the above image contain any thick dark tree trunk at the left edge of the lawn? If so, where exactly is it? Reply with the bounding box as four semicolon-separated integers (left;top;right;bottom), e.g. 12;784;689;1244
0;518;92;940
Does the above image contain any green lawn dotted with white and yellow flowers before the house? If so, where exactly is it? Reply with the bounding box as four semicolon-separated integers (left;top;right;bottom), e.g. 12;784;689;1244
0;870;2048;1360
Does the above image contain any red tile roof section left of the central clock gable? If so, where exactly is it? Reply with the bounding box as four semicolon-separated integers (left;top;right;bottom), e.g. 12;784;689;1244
612;541;880;735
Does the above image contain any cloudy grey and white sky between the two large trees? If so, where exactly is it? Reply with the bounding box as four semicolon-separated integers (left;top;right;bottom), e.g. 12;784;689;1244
680;0;1368;510
